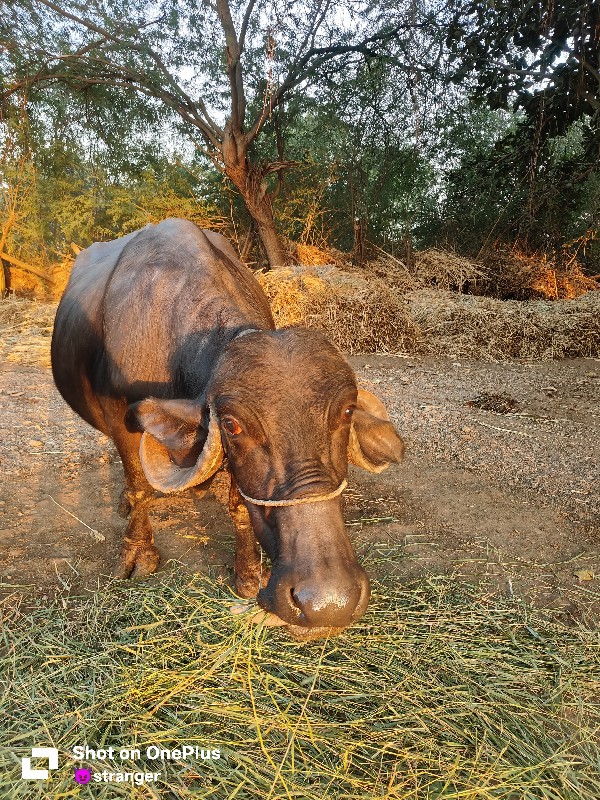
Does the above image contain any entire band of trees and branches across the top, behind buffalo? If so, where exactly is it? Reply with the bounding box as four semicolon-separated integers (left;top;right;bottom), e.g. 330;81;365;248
0;0;600;276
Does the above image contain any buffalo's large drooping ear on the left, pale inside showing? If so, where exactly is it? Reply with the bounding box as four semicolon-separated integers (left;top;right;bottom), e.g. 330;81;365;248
125;397;223;492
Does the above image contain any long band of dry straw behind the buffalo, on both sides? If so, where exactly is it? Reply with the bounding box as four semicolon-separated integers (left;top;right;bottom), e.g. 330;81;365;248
0;266;600;366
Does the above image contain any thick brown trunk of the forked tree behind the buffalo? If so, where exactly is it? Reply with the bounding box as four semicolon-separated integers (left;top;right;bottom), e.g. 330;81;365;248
222;128;287;269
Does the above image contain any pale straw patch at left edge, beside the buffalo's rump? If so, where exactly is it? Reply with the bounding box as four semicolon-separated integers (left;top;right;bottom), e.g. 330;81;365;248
0;298;56;367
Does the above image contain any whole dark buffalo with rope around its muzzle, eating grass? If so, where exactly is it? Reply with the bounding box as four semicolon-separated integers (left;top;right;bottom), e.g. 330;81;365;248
52;219;403;632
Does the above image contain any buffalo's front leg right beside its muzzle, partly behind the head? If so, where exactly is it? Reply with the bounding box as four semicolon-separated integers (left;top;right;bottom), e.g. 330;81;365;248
229;475;270;597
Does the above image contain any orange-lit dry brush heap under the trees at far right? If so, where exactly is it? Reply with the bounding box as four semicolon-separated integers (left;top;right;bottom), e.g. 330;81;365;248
480;250;600;300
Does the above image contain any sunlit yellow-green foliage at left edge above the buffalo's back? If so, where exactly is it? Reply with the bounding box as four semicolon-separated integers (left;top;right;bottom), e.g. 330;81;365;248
0;101;223;276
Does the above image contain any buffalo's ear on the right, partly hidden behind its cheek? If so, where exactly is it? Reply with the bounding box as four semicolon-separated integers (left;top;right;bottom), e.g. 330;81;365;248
348;389;404;472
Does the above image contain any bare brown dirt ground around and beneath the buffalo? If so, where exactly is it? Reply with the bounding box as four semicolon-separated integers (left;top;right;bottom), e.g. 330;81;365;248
0;338;600;624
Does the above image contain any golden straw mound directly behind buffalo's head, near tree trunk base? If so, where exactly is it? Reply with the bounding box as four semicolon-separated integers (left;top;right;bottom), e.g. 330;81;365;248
257;266;418;353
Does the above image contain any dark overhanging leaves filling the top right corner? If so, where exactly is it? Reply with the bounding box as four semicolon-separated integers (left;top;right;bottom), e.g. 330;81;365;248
447;0;600;128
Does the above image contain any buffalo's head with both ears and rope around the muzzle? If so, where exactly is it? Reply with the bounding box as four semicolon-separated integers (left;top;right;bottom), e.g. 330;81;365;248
130;328;403;632
